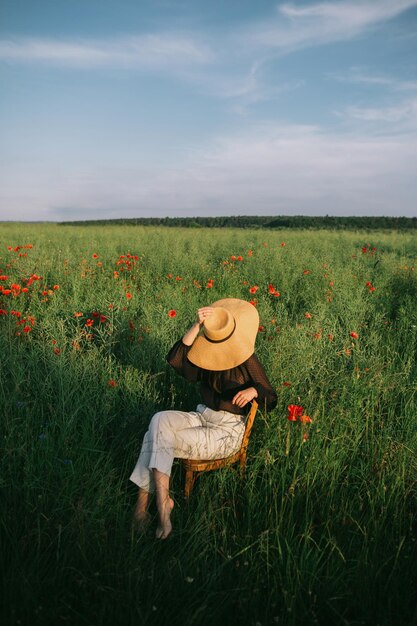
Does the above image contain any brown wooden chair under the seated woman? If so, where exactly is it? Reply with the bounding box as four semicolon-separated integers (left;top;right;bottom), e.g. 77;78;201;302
182;400;258;498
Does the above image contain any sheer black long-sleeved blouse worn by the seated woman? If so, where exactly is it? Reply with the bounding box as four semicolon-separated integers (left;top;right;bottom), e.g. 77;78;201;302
167;339;277;415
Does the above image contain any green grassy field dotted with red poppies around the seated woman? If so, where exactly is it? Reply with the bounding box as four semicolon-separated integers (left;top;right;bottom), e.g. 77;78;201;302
0;224;417;626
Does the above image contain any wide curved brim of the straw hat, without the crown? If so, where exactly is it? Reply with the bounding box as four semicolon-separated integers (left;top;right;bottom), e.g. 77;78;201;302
187;298;259;371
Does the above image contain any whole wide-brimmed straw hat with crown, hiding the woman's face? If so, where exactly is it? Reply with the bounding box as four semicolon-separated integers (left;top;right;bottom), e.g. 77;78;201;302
187;298;259;372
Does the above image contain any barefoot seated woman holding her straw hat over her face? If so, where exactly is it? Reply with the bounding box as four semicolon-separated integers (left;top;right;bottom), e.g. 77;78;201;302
130;298;276;539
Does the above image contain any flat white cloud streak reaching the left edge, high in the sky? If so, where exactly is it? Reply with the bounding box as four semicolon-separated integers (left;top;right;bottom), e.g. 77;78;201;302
0;34;213;69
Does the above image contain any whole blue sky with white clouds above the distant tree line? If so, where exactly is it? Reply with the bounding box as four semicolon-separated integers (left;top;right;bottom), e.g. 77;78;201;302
0;0;417;221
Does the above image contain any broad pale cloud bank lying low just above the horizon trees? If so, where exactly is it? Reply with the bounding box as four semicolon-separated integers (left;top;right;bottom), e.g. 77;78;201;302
0;125;417;220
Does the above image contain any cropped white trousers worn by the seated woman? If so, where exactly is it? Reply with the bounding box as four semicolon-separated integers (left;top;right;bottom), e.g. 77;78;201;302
130;404;245;491
